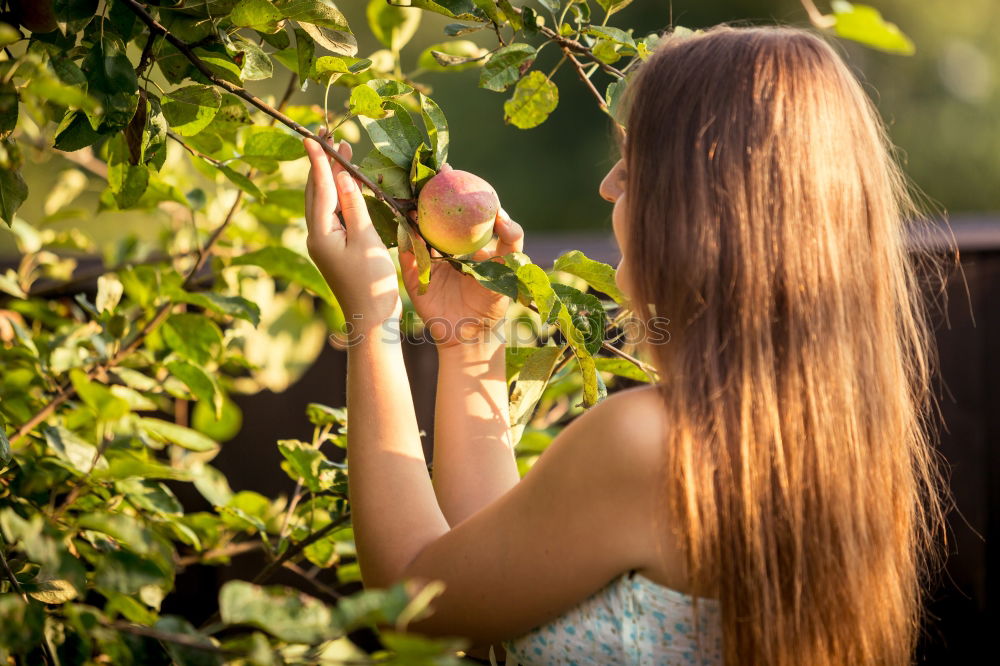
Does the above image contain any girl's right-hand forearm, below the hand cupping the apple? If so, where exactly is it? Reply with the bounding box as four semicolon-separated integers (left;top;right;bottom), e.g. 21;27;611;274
433;343;520;526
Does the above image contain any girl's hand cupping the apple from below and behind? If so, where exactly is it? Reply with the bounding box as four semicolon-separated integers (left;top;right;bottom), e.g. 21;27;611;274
399;188;524;349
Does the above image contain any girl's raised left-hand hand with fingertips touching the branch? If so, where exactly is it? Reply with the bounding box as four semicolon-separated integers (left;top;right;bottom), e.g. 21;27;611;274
305;139;402;332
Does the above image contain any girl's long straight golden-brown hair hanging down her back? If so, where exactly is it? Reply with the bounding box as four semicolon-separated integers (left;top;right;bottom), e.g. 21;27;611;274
623;27;945;666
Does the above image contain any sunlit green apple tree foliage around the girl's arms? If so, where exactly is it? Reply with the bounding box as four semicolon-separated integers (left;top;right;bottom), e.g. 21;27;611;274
0;0;912;664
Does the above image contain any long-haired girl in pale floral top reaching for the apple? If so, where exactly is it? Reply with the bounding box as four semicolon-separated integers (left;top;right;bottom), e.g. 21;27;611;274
306;27;943;666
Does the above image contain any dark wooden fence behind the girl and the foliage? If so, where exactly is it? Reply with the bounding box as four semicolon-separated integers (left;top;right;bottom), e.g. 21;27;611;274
0;217;1000;665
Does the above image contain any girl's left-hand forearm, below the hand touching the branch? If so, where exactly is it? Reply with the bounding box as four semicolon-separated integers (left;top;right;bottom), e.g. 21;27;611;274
347;322;449;587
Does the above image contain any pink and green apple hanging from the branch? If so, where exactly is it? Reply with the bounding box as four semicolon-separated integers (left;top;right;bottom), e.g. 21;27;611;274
417;169;500;255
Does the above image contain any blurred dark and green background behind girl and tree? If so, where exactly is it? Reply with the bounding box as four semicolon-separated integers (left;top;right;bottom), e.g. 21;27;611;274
0;0;1000;664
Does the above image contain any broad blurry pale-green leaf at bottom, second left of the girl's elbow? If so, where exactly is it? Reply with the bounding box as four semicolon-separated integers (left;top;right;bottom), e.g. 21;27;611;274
219;580;340;644
